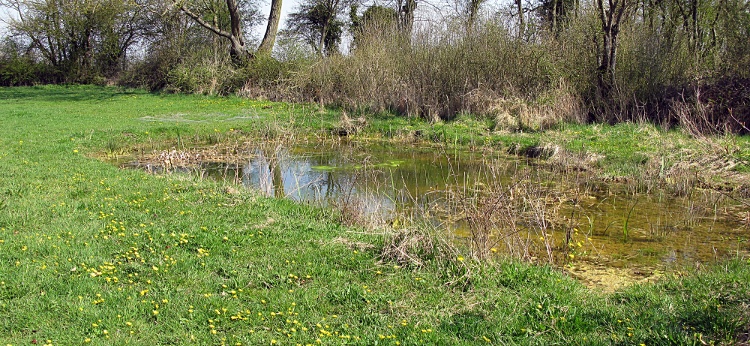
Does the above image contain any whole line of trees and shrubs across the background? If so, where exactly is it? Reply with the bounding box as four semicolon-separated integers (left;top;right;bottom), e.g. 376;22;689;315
0;0;750;133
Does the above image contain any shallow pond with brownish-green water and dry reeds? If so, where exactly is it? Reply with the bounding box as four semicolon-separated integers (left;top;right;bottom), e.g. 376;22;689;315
119;141;750;290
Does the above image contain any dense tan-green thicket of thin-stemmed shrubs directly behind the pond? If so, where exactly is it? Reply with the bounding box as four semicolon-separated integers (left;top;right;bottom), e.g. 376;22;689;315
294;19;581;127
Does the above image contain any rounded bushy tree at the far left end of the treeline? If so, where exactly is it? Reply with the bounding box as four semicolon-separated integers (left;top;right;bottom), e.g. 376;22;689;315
0;0;150;82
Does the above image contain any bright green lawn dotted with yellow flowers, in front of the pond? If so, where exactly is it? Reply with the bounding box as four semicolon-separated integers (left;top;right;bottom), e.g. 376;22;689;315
0;87;750;345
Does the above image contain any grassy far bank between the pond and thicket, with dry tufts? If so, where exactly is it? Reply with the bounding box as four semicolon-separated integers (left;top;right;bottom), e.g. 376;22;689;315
369;115;750;183
